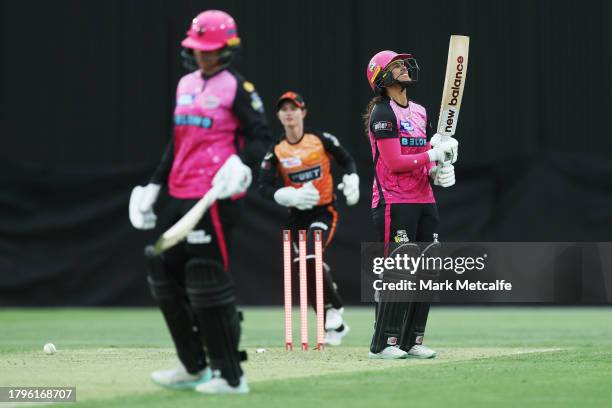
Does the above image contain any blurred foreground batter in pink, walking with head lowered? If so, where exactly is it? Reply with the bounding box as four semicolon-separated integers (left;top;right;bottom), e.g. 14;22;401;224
130;10;271;394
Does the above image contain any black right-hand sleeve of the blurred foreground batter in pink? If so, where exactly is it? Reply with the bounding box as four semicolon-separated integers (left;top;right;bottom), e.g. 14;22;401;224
232;73;272;168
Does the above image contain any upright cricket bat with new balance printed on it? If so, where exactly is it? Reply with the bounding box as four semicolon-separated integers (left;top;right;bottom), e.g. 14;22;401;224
438;35;470;161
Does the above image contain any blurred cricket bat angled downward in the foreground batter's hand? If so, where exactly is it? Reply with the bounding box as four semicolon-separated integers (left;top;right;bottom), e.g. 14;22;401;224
153;184;222;255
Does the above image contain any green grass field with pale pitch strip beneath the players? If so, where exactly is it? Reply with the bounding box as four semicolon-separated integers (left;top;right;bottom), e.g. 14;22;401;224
0;307;612;408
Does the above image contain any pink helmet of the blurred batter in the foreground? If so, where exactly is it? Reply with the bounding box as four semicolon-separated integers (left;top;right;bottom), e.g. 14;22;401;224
181;10;240;51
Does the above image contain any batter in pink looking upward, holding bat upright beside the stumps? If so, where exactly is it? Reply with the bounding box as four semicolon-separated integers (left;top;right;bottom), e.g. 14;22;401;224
364;51;458;359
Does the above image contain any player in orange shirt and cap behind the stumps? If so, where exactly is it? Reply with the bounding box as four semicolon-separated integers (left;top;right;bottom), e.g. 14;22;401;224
259;91;359;346
